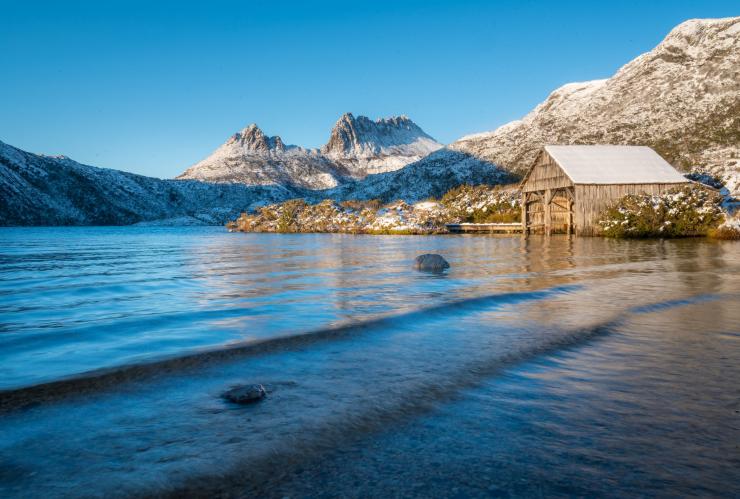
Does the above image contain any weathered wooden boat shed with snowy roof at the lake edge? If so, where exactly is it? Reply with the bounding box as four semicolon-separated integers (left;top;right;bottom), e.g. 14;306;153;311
520;145;689;235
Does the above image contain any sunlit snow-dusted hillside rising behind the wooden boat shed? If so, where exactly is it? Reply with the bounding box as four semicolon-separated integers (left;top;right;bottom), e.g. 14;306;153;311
448;17;740;195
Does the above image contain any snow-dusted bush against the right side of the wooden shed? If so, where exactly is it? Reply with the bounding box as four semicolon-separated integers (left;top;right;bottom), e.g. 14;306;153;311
599;186;724;238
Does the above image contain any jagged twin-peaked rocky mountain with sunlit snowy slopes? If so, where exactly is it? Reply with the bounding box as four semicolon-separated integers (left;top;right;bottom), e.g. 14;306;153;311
178;113;442;189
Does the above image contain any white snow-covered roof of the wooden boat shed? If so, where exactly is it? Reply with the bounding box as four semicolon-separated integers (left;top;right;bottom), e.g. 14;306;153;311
545;145;688;184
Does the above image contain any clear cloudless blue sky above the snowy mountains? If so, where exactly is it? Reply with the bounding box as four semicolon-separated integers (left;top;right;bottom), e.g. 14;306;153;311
0;0;740;177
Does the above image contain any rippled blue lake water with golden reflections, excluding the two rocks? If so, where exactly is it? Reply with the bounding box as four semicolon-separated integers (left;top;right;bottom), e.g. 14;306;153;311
0;227;740;498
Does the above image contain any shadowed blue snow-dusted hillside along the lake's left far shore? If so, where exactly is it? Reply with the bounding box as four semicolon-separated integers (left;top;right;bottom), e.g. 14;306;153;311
0;142;296;225
